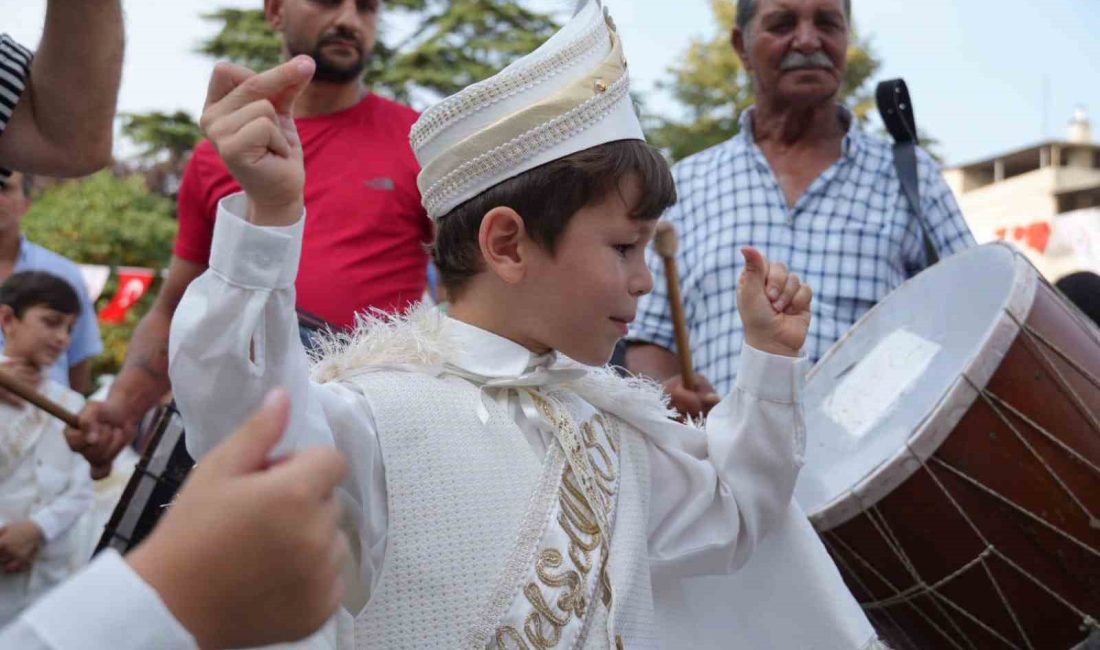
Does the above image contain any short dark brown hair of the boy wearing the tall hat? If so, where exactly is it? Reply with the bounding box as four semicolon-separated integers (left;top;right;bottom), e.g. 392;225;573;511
431;140;677;298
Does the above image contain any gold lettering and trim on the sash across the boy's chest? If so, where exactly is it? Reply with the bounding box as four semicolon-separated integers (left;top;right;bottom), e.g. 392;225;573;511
495;399;619;650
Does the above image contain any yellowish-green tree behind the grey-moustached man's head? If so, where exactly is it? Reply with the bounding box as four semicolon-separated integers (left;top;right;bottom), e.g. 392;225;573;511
647;0;880;161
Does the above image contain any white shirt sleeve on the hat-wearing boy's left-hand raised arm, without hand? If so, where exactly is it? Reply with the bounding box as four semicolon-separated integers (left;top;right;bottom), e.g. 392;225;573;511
168;194;386;585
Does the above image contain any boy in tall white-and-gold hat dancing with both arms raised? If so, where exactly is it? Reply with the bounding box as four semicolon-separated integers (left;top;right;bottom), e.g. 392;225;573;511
169;1;840;649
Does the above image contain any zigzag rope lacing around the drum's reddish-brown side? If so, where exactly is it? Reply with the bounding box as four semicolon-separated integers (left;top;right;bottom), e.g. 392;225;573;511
823;313;1100;649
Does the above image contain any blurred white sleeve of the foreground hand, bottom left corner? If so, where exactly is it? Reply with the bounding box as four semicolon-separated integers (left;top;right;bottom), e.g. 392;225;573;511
0;550;196;650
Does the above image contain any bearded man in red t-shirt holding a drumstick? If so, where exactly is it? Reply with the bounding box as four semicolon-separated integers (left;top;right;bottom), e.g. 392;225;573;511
80;0;431;474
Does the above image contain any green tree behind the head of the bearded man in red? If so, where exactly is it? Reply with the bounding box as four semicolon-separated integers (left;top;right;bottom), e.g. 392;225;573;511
199;0;559;102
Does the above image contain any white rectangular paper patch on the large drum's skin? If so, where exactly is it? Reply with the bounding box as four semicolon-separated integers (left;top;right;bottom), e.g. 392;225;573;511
823;330;941;440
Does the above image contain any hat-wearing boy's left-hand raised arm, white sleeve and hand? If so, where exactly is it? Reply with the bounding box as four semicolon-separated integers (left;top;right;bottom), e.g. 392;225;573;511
169;57;316;455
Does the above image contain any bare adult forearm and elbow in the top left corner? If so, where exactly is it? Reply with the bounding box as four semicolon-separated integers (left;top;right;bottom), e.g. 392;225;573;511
0;0;123;176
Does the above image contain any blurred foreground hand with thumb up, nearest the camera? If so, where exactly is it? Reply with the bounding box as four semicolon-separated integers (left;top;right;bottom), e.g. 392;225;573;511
128;392;348;648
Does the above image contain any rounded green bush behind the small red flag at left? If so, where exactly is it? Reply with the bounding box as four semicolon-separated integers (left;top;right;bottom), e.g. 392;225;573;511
23;172;176;376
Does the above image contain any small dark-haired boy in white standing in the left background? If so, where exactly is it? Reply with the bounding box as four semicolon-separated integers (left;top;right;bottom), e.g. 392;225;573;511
0;272;92;626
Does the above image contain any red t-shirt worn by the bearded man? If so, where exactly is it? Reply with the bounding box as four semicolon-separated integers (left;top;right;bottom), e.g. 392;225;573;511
174;95;431;328
